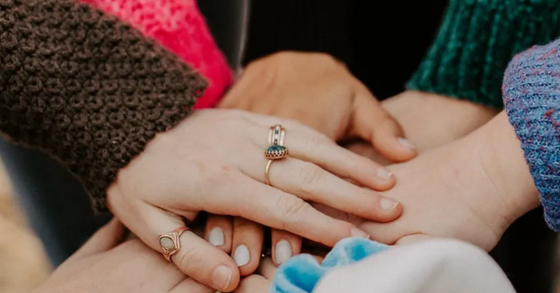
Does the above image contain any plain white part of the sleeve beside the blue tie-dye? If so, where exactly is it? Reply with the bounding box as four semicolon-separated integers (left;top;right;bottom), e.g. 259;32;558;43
313;240;515;293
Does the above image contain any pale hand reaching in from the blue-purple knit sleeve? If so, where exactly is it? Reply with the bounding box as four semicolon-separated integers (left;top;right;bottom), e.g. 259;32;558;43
353;113;539;251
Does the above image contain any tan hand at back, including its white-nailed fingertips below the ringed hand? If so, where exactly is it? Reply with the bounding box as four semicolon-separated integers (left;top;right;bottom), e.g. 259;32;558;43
217;52;416;276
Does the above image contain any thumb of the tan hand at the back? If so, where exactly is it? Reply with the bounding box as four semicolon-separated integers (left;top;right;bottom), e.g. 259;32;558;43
352;87;417;162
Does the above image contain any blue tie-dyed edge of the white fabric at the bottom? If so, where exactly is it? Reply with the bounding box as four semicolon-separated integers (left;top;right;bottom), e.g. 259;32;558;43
269;238;389;293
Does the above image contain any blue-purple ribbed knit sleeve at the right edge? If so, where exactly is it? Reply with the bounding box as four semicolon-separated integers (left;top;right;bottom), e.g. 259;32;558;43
503;40;560;232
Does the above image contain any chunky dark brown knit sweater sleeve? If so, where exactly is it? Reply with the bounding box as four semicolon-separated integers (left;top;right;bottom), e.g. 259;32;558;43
0;0;206;210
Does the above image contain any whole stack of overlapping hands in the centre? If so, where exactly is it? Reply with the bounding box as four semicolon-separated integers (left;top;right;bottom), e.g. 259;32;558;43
32;52;538;293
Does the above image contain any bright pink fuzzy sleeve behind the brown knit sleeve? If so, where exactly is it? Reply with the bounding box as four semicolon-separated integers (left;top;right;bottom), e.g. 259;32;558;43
81;0;233;109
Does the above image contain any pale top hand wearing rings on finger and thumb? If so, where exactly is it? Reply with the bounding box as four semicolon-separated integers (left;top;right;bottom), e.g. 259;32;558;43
107;110;402;292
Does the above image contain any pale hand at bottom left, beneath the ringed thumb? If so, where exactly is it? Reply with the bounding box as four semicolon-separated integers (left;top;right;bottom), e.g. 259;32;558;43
32;220;215;293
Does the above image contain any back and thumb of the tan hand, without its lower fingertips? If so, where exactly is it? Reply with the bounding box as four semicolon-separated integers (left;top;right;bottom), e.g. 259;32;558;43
220;52;416;162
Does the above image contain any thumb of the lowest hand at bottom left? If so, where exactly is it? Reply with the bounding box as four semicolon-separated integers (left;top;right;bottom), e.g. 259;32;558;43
70;218;125;259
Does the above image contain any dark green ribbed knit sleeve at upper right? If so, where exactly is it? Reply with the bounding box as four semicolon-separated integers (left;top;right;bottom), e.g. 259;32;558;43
407;0;560;108
